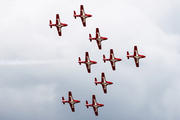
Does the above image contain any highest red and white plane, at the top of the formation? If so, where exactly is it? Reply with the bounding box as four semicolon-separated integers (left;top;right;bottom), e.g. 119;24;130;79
74;5;92;27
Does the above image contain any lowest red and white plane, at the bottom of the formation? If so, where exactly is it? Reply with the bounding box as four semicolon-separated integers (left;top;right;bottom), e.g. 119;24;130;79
86;95;104;116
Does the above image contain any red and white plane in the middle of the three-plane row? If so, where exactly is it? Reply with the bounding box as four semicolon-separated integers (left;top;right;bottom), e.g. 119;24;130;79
103;49;122;70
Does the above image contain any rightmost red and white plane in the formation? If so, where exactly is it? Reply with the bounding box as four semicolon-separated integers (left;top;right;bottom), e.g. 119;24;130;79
127;46;146;67
